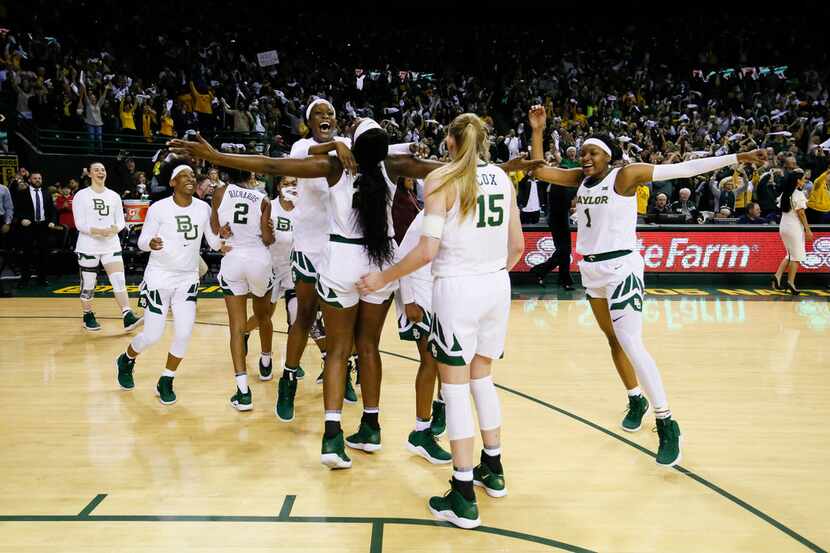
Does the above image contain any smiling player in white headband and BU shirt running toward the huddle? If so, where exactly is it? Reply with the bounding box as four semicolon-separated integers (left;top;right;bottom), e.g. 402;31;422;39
116;163;221;405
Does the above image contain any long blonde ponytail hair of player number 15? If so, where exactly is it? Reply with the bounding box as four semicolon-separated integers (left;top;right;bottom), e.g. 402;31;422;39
429;113;490;220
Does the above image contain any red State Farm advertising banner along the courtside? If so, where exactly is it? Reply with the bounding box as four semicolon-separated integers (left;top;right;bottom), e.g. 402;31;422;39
513;227;830;273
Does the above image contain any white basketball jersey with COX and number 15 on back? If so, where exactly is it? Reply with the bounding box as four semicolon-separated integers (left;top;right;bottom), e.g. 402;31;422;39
432;164;513;277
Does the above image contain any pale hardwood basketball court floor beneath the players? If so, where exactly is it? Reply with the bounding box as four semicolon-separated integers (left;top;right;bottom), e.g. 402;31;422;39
0;291;830;553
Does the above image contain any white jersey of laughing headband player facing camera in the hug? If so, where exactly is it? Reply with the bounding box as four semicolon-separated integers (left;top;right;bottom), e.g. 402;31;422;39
290;136;352;252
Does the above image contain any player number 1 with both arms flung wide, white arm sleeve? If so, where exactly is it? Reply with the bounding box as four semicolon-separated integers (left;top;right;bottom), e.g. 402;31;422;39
529;106;766;467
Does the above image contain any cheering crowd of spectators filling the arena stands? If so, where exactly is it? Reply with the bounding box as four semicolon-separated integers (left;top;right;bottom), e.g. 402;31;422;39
0;7;830;284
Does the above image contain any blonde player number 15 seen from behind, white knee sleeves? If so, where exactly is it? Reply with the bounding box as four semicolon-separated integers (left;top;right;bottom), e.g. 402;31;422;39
360;113;524;528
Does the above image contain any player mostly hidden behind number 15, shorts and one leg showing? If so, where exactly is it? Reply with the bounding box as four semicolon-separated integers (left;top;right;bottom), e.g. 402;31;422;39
395;211;452;465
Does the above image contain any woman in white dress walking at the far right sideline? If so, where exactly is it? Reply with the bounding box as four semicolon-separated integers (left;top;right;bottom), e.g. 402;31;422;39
772;169;813;296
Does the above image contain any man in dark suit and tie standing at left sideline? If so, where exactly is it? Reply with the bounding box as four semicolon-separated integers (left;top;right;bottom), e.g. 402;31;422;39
13;173;58;286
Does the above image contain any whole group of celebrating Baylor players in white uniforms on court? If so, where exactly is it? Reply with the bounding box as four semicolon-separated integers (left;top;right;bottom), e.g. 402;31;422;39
75;99;763;528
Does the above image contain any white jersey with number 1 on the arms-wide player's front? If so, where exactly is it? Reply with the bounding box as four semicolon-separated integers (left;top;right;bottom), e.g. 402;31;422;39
576;169;637;256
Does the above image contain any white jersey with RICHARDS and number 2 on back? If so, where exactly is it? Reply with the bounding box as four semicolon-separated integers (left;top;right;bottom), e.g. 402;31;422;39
219;184;266;254
